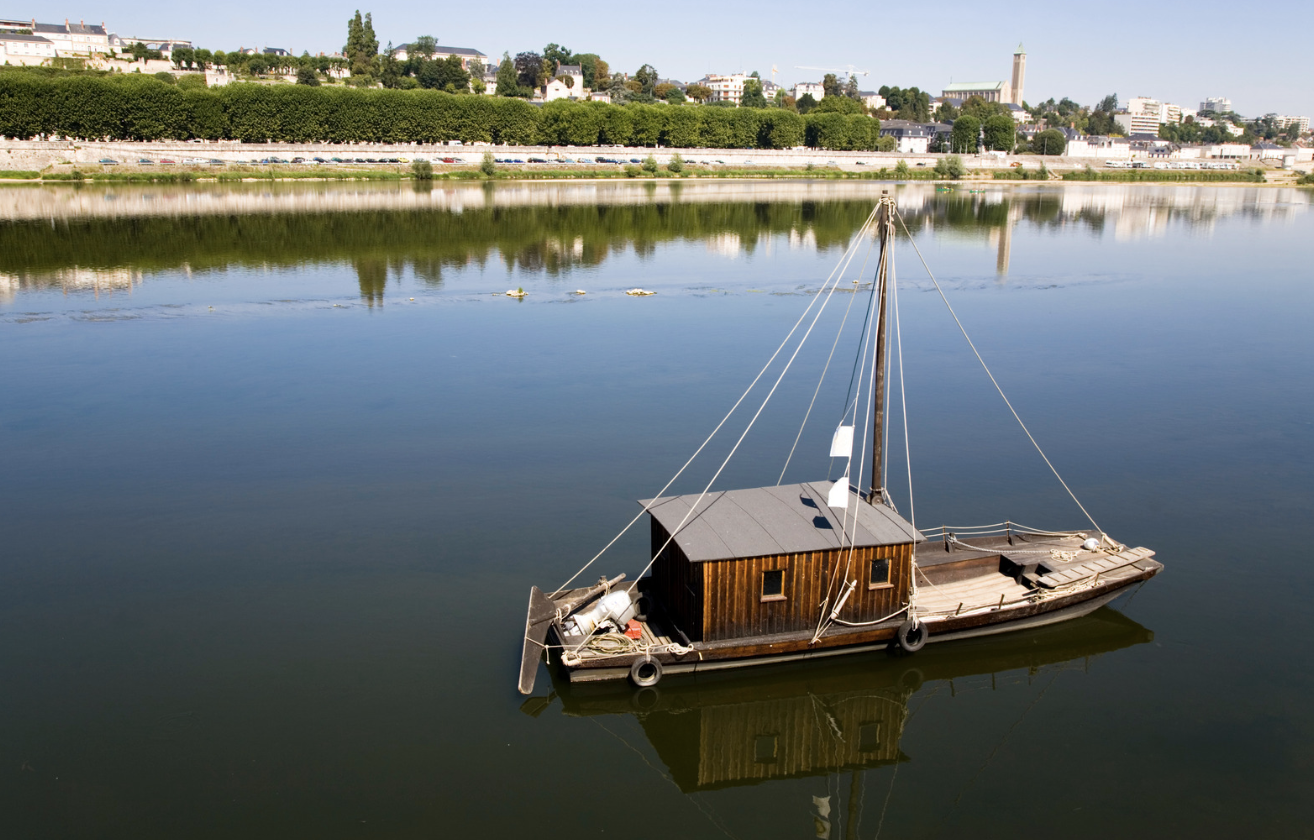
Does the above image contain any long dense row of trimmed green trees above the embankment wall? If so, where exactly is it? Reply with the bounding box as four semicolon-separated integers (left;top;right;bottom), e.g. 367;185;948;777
0;72;888;151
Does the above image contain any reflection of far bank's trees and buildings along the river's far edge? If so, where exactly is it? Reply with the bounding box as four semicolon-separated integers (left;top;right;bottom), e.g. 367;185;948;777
0;181;1309;305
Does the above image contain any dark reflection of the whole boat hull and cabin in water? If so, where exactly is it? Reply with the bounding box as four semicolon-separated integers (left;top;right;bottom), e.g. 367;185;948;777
522;607;1154;799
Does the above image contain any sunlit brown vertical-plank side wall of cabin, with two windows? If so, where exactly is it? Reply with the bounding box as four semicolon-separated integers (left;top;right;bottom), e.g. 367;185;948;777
699;543;912;642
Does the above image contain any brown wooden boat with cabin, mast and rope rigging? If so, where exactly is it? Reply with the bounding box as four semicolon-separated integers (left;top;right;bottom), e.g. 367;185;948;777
519;196;1163;694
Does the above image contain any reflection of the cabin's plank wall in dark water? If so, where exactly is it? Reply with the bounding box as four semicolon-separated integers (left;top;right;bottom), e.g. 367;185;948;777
698;691;908;787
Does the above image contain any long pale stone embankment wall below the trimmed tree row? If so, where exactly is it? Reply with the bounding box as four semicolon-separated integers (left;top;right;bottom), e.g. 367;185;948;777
0;139;1104;171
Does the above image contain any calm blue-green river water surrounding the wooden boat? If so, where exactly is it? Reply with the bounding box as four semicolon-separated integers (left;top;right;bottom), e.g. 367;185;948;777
0;183;1314;839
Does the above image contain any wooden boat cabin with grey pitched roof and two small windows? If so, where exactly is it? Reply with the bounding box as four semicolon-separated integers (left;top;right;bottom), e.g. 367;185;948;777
643;481;925;642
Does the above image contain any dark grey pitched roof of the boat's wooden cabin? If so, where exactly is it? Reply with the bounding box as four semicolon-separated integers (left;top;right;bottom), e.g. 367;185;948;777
640;481;925;563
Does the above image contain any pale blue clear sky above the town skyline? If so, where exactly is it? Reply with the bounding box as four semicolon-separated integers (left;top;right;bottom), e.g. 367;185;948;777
35;0;1314;117
